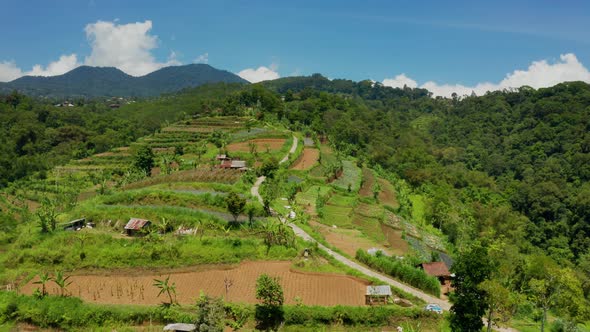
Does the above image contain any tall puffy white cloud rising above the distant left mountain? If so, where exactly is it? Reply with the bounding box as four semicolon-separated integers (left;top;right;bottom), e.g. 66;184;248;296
84;20;180;76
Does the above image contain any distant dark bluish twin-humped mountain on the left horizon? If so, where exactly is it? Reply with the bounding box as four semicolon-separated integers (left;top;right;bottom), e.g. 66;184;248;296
0;64;248;98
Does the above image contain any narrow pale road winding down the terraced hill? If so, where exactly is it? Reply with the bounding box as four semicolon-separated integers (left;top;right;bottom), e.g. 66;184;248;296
250;136;516;332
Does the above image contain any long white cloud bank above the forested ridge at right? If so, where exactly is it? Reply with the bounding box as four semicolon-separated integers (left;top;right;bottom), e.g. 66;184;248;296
383;53;590;97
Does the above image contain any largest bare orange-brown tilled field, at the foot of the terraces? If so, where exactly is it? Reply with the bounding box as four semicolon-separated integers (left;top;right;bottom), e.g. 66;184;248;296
22;261;368;306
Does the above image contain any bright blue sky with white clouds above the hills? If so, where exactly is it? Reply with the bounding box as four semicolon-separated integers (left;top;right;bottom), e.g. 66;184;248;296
0;0;590;95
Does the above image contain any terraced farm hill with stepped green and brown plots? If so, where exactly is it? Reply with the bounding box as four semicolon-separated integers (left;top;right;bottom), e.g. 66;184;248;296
3;112;448;332
